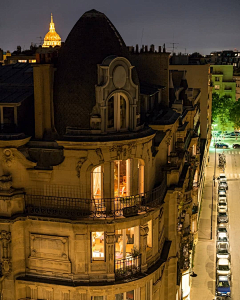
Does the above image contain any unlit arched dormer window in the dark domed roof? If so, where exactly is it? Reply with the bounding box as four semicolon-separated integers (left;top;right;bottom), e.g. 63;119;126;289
107;93;129;131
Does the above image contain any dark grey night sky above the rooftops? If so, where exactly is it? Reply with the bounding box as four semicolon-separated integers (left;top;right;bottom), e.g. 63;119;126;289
0;0;240;54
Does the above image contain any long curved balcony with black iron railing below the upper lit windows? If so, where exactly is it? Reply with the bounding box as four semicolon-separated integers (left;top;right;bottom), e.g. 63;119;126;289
25;178;167;220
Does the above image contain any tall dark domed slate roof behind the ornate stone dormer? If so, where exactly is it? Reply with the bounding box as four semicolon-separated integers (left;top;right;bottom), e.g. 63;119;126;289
54;10;138;135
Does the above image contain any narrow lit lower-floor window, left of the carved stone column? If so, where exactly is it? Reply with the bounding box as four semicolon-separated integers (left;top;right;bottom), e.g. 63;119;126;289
91;231;105;260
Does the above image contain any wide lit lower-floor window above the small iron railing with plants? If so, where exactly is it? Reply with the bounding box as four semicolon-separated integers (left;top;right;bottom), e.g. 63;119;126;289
115;226;139;260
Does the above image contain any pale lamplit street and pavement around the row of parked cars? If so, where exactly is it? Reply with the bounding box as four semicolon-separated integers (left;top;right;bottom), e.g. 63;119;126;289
191;139;240;300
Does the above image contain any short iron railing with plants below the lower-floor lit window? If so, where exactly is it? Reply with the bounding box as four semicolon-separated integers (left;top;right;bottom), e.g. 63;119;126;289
115;254;141;280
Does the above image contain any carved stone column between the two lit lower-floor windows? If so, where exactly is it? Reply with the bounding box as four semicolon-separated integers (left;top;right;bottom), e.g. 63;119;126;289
106;232;115;281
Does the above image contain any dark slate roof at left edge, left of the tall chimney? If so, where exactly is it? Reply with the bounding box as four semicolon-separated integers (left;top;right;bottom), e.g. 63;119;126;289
0;63;34;104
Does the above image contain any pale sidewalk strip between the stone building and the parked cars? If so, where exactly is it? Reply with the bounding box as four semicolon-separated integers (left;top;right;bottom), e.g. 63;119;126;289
190;153;216;300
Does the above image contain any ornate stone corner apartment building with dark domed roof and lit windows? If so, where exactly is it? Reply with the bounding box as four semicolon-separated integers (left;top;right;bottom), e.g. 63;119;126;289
0;10;210;300
